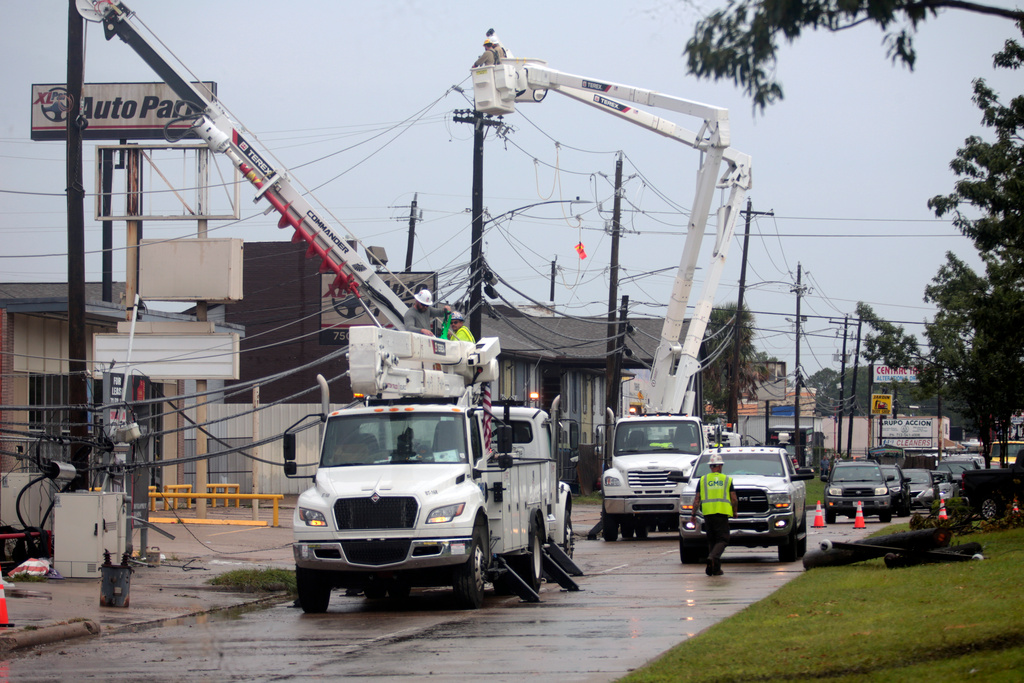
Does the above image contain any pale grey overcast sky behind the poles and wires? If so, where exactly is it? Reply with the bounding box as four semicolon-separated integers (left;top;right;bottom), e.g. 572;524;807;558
0;0;1022;401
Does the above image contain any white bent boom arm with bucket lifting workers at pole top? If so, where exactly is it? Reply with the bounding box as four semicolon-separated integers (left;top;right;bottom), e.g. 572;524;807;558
473;59;751;413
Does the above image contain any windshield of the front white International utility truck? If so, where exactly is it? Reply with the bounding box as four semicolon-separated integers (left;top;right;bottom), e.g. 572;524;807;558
321;413;468;467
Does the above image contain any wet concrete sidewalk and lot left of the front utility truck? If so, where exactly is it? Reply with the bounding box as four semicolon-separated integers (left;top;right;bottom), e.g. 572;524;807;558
0;496;296;651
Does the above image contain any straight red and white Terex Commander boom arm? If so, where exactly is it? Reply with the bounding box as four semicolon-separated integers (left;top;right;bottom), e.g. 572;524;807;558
78;0;408;330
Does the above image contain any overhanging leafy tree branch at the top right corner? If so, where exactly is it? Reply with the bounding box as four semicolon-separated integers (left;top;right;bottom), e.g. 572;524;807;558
686;0;1024;111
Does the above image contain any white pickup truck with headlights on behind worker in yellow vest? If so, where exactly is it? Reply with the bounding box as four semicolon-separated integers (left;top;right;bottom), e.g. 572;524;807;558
674;446;814;564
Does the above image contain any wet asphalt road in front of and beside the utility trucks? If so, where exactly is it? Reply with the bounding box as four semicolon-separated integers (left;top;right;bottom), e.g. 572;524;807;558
0;510;879;683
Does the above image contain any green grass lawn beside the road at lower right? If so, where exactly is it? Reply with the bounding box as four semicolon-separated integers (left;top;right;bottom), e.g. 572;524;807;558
623;527;1024;683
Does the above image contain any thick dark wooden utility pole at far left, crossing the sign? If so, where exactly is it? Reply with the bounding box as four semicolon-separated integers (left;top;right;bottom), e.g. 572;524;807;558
67;0;90;490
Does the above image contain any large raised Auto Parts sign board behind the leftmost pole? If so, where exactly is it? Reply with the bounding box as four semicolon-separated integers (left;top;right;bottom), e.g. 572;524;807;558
32;82;217;140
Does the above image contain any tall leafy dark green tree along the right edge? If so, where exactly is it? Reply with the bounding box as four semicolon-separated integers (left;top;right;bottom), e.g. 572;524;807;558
858;26;1024;464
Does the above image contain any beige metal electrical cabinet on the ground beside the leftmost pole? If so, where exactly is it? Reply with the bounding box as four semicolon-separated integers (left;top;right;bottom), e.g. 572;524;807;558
53;492;128;579
